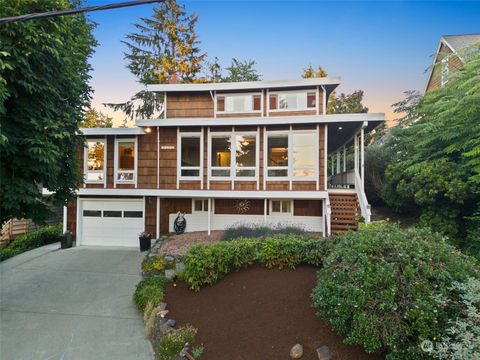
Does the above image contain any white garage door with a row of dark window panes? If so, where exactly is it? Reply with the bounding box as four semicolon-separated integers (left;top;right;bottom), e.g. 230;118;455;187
79;199;144;247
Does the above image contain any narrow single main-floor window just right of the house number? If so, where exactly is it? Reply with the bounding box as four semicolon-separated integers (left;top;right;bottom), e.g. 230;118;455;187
180;134;201;178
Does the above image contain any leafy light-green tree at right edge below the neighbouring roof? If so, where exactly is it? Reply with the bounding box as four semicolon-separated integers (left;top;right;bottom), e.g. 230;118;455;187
383;55;480;255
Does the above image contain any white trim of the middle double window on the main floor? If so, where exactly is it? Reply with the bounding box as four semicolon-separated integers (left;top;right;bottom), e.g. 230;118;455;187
208;130;260;182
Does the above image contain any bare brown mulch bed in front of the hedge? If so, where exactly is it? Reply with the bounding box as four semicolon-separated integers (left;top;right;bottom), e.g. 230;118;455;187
166;265;384;360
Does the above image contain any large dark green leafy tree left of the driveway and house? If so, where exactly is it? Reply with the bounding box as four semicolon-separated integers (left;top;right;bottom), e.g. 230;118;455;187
0;0;96;223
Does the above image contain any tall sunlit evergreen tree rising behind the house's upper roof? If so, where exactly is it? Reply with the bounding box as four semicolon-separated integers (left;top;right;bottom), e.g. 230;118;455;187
105;0;206;119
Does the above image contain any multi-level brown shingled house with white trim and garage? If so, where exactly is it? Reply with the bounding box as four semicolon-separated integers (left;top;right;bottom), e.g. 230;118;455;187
64;77;384;246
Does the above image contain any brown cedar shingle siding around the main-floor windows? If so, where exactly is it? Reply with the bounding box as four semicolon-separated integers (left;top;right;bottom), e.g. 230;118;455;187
83;124;325;191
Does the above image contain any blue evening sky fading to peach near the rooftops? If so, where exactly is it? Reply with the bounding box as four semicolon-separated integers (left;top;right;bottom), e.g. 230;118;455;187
87;0;480;125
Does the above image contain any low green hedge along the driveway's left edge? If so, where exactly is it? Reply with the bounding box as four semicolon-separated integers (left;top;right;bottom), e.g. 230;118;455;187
0;224;62;261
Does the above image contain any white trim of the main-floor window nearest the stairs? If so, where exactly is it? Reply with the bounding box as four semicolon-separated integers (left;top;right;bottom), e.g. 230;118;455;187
263;127;320;183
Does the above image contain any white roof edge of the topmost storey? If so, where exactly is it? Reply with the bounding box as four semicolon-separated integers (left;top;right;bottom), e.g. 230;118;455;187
147;76;340;92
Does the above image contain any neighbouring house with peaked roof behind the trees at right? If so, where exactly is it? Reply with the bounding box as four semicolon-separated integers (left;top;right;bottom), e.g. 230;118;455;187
425;34;480;92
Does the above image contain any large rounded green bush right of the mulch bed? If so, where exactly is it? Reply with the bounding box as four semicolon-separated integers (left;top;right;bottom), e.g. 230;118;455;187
312;223;477;359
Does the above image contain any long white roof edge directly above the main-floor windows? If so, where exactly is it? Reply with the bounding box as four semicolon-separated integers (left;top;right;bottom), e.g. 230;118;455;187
136;113;385;127
